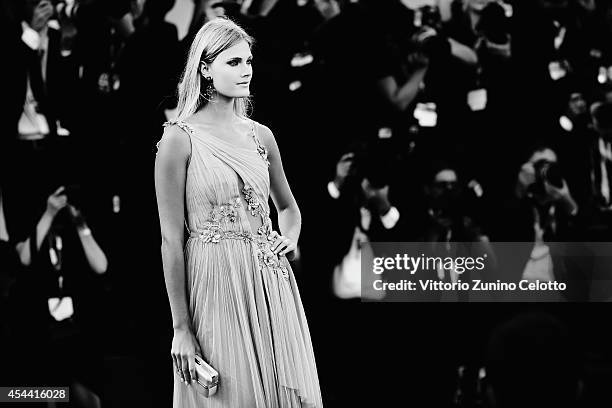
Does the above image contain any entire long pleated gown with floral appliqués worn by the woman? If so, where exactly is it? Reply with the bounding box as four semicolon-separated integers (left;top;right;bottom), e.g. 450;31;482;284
158;121;322;408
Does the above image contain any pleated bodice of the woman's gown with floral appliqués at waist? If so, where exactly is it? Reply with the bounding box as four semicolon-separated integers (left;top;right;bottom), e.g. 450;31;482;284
160;116;287;278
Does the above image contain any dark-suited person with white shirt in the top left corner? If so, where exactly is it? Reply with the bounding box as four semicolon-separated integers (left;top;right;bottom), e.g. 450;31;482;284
2;0;78;159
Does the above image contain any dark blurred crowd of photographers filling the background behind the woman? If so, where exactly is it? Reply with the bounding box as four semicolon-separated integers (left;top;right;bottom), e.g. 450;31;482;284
0;0;612;407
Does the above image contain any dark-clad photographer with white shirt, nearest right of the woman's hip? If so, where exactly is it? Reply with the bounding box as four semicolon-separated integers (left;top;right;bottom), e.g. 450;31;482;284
302;142;408;406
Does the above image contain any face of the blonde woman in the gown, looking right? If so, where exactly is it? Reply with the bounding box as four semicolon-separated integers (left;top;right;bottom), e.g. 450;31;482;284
201;41;253;98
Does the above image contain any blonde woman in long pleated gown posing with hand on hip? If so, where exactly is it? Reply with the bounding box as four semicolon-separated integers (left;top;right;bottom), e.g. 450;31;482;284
155;19;322;408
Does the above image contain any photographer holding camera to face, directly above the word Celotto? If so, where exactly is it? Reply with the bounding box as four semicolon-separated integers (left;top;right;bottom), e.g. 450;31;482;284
492;145;591;301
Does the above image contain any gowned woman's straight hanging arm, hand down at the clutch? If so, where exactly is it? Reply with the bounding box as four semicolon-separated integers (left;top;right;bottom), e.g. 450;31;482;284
155;126;201;384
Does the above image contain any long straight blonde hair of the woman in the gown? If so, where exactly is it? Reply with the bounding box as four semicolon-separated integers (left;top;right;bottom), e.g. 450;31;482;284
175;17;254;121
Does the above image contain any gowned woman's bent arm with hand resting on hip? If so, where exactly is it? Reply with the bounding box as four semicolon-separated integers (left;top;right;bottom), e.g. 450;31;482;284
258;126;302;260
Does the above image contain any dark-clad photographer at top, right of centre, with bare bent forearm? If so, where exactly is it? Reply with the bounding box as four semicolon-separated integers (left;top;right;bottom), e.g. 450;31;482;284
373;1;478;150
